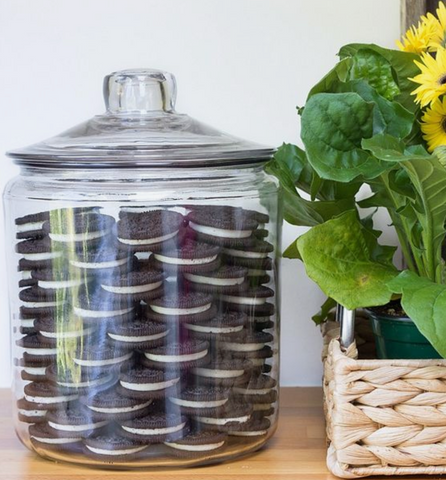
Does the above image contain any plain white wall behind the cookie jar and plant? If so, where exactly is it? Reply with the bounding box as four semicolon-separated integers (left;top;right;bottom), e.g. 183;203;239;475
0;0;399;387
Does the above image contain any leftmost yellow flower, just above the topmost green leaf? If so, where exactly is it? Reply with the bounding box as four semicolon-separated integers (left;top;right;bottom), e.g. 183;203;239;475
396;14;443;54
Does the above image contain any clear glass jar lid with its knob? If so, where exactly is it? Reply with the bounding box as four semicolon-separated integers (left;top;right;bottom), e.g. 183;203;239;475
7;69;274;168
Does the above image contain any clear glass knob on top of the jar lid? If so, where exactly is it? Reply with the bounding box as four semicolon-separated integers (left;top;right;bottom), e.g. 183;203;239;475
104;69;177;114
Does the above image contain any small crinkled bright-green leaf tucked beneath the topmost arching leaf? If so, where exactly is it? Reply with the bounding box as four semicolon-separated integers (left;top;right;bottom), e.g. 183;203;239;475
341;48;401;100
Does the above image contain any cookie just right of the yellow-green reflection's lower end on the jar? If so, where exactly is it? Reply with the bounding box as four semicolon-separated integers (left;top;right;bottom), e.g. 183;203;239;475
73;342;133;370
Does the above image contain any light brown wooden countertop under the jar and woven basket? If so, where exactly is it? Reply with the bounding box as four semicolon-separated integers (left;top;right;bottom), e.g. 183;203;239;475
0;388;440;480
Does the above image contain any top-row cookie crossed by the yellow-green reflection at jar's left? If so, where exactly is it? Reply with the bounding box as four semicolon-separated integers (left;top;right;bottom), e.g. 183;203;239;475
43;212;115;247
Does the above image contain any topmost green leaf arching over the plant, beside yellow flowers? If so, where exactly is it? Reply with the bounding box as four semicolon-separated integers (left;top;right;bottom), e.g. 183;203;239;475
339;43;419;113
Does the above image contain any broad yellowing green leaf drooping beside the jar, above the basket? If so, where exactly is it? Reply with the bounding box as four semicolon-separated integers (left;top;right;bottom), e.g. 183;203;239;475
297;210;398;310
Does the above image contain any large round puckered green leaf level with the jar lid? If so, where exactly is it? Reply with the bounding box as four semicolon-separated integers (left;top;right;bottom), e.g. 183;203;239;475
301;93;389;182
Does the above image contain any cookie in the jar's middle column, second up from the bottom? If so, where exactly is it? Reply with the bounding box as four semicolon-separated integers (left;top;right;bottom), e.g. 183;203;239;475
117;366;181;399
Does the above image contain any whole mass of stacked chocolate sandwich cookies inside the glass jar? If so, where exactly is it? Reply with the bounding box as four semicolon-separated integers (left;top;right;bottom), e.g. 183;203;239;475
16;206;277;461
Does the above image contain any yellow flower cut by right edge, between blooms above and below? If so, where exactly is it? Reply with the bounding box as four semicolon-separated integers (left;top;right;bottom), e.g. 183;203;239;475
410;47;446;107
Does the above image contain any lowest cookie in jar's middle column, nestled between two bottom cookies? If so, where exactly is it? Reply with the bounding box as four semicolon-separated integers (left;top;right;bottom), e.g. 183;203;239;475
119;412;188;443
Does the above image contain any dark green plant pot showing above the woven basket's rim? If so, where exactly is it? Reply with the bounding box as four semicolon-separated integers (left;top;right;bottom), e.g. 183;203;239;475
367;310;442;359
